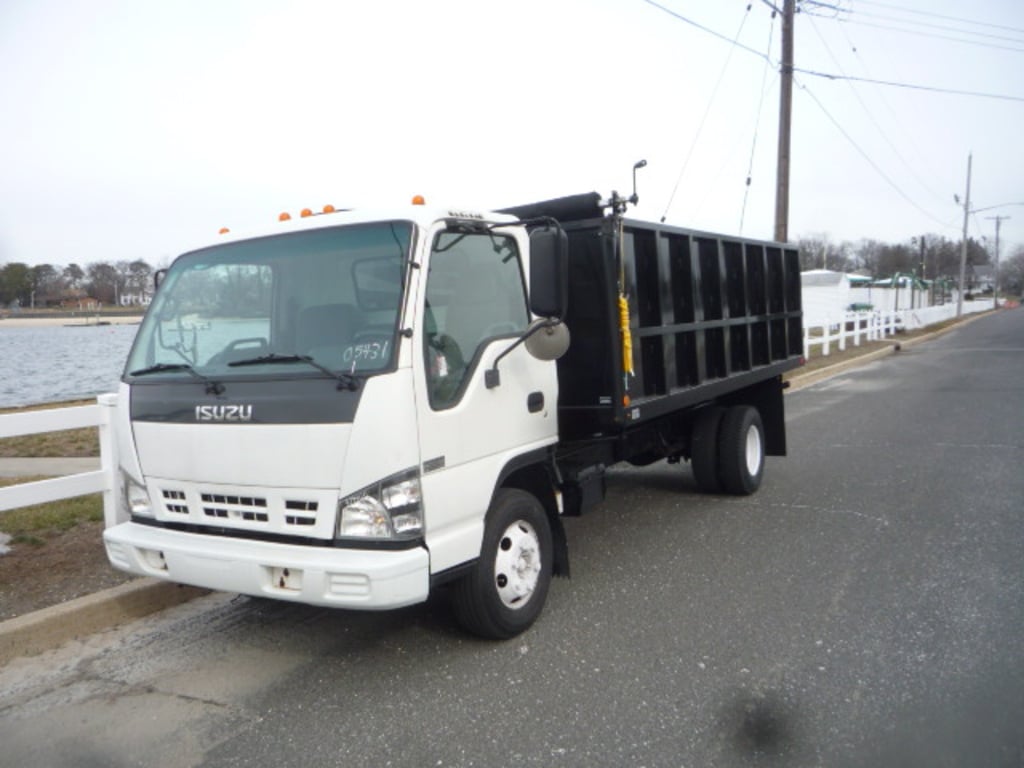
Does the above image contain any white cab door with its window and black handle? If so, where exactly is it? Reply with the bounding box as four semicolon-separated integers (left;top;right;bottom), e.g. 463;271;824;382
417;230;557;572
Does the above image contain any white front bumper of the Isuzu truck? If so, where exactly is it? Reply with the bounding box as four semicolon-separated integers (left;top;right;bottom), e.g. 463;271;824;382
103;522;430;610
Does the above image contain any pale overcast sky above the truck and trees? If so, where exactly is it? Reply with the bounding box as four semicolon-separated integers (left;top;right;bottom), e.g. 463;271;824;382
0;0;1024;266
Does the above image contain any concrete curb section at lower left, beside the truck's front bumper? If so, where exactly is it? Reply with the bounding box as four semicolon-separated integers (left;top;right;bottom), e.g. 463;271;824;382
0;579;210;666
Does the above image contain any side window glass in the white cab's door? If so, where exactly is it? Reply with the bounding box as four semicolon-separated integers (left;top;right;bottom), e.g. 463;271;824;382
424;231;529;410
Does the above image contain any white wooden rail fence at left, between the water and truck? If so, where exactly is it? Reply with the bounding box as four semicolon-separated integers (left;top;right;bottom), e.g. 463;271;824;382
0;394;118;525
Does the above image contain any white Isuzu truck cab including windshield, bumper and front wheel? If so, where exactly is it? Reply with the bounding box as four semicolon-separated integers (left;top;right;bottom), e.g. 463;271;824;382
103;201;565;637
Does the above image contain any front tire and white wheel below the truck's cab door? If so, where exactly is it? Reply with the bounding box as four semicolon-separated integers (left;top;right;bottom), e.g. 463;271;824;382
452;488;554;640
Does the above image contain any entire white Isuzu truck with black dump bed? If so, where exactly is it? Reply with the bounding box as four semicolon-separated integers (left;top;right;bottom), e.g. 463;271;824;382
103;194;802;638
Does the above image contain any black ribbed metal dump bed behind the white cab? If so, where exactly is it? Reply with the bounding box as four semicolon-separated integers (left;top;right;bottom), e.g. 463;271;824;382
499;194;803;440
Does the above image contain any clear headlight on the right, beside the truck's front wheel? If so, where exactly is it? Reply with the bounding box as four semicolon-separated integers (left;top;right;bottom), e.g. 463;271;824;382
336;469;423;541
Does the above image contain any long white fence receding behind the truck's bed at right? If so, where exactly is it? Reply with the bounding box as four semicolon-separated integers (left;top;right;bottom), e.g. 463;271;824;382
804;301;992;357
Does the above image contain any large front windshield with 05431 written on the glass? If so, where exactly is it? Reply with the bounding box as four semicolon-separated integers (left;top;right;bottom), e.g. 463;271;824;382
125;221;413;381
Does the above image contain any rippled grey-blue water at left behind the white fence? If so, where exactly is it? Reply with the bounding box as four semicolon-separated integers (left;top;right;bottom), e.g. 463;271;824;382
0;324;138;408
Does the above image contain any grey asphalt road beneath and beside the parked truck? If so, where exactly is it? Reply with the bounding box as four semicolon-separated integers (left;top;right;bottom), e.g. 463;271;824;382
0;310;1024;768
